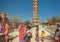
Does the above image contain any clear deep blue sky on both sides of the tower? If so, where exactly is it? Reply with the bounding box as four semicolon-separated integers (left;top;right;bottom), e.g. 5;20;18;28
0;0;60;21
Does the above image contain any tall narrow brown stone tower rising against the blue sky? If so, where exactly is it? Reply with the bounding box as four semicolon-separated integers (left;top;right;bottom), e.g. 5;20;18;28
33;0;39;25
